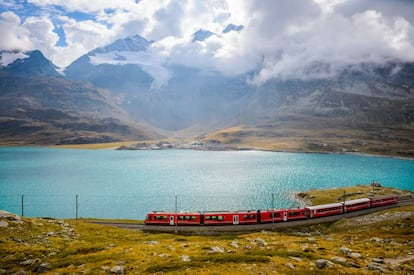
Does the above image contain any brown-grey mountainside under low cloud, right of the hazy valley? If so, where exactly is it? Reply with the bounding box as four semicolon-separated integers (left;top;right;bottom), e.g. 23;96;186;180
198;63;414;157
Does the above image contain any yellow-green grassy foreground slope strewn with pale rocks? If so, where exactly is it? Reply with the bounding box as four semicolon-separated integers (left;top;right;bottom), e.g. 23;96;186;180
0;184;414;274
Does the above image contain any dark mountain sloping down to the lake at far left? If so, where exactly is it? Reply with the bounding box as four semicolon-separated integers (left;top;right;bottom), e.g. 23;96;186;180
0;51;159;144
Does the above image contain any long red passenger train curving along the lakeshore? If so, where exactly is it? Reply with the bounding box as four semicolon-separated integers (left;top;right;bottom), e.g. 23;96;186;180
145;196;398;225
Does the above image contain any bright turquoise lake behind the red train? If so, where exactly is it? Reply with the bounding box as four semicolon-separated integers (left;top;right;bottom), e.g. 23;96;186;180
0;147;414;219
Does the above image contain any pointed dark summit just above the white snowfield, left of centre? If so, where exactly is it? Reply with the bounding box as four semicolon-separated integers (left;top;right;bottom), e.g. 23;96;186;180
93;34;153;53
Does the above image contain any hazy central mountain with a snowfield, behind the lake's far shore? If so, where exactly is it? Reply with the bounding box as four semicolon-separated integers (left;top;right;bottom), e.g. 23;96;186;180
64;34;251;131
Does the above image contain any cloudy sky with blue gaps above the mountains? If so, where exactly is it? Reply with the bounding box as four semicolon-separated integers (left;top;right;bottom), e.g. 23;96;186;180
0;0;414;84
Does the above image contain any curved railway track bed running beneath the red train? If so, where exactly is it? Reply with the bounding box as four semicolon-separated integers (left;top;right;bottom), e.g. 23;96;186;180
91;198;414;235
